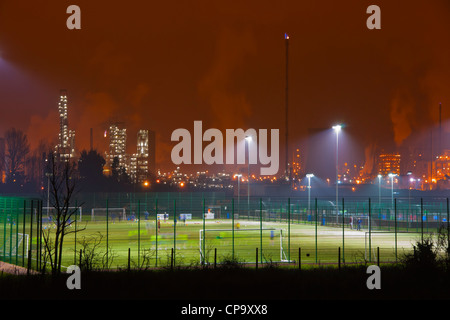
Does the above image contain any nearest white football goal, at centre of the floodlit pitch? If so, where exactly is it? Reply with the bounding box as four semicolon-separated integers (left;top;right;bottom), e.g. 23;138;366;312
199;228;289;263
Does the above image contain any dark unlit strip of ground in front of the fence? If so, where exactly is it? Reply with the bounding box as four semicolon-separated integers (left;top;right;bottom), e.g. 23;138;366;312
0;266;450;303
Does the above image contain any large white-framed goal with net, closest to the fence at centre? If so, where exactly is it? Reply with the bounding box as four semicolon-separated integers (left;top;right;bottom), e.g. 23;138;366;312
199;228;289;263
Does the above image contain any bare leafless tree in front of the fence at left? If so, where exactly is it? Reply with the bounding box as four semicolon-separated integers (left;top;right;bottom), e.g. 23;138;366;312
43;152;85;274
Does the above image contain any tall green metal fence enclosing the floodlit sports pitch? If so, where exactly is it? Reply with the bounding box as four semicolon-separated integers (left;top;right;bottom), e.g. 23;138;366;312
0;192;449;269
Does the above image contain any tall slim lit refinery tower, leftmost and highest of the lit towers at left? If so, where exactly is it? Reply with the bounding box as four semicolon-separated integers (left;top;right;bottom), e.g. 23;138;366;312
55;90;75;160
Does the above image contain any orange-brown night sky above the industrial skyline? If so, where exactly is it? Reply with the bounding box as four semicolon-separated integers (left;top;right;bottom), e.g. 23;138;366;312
0;0;450;175
